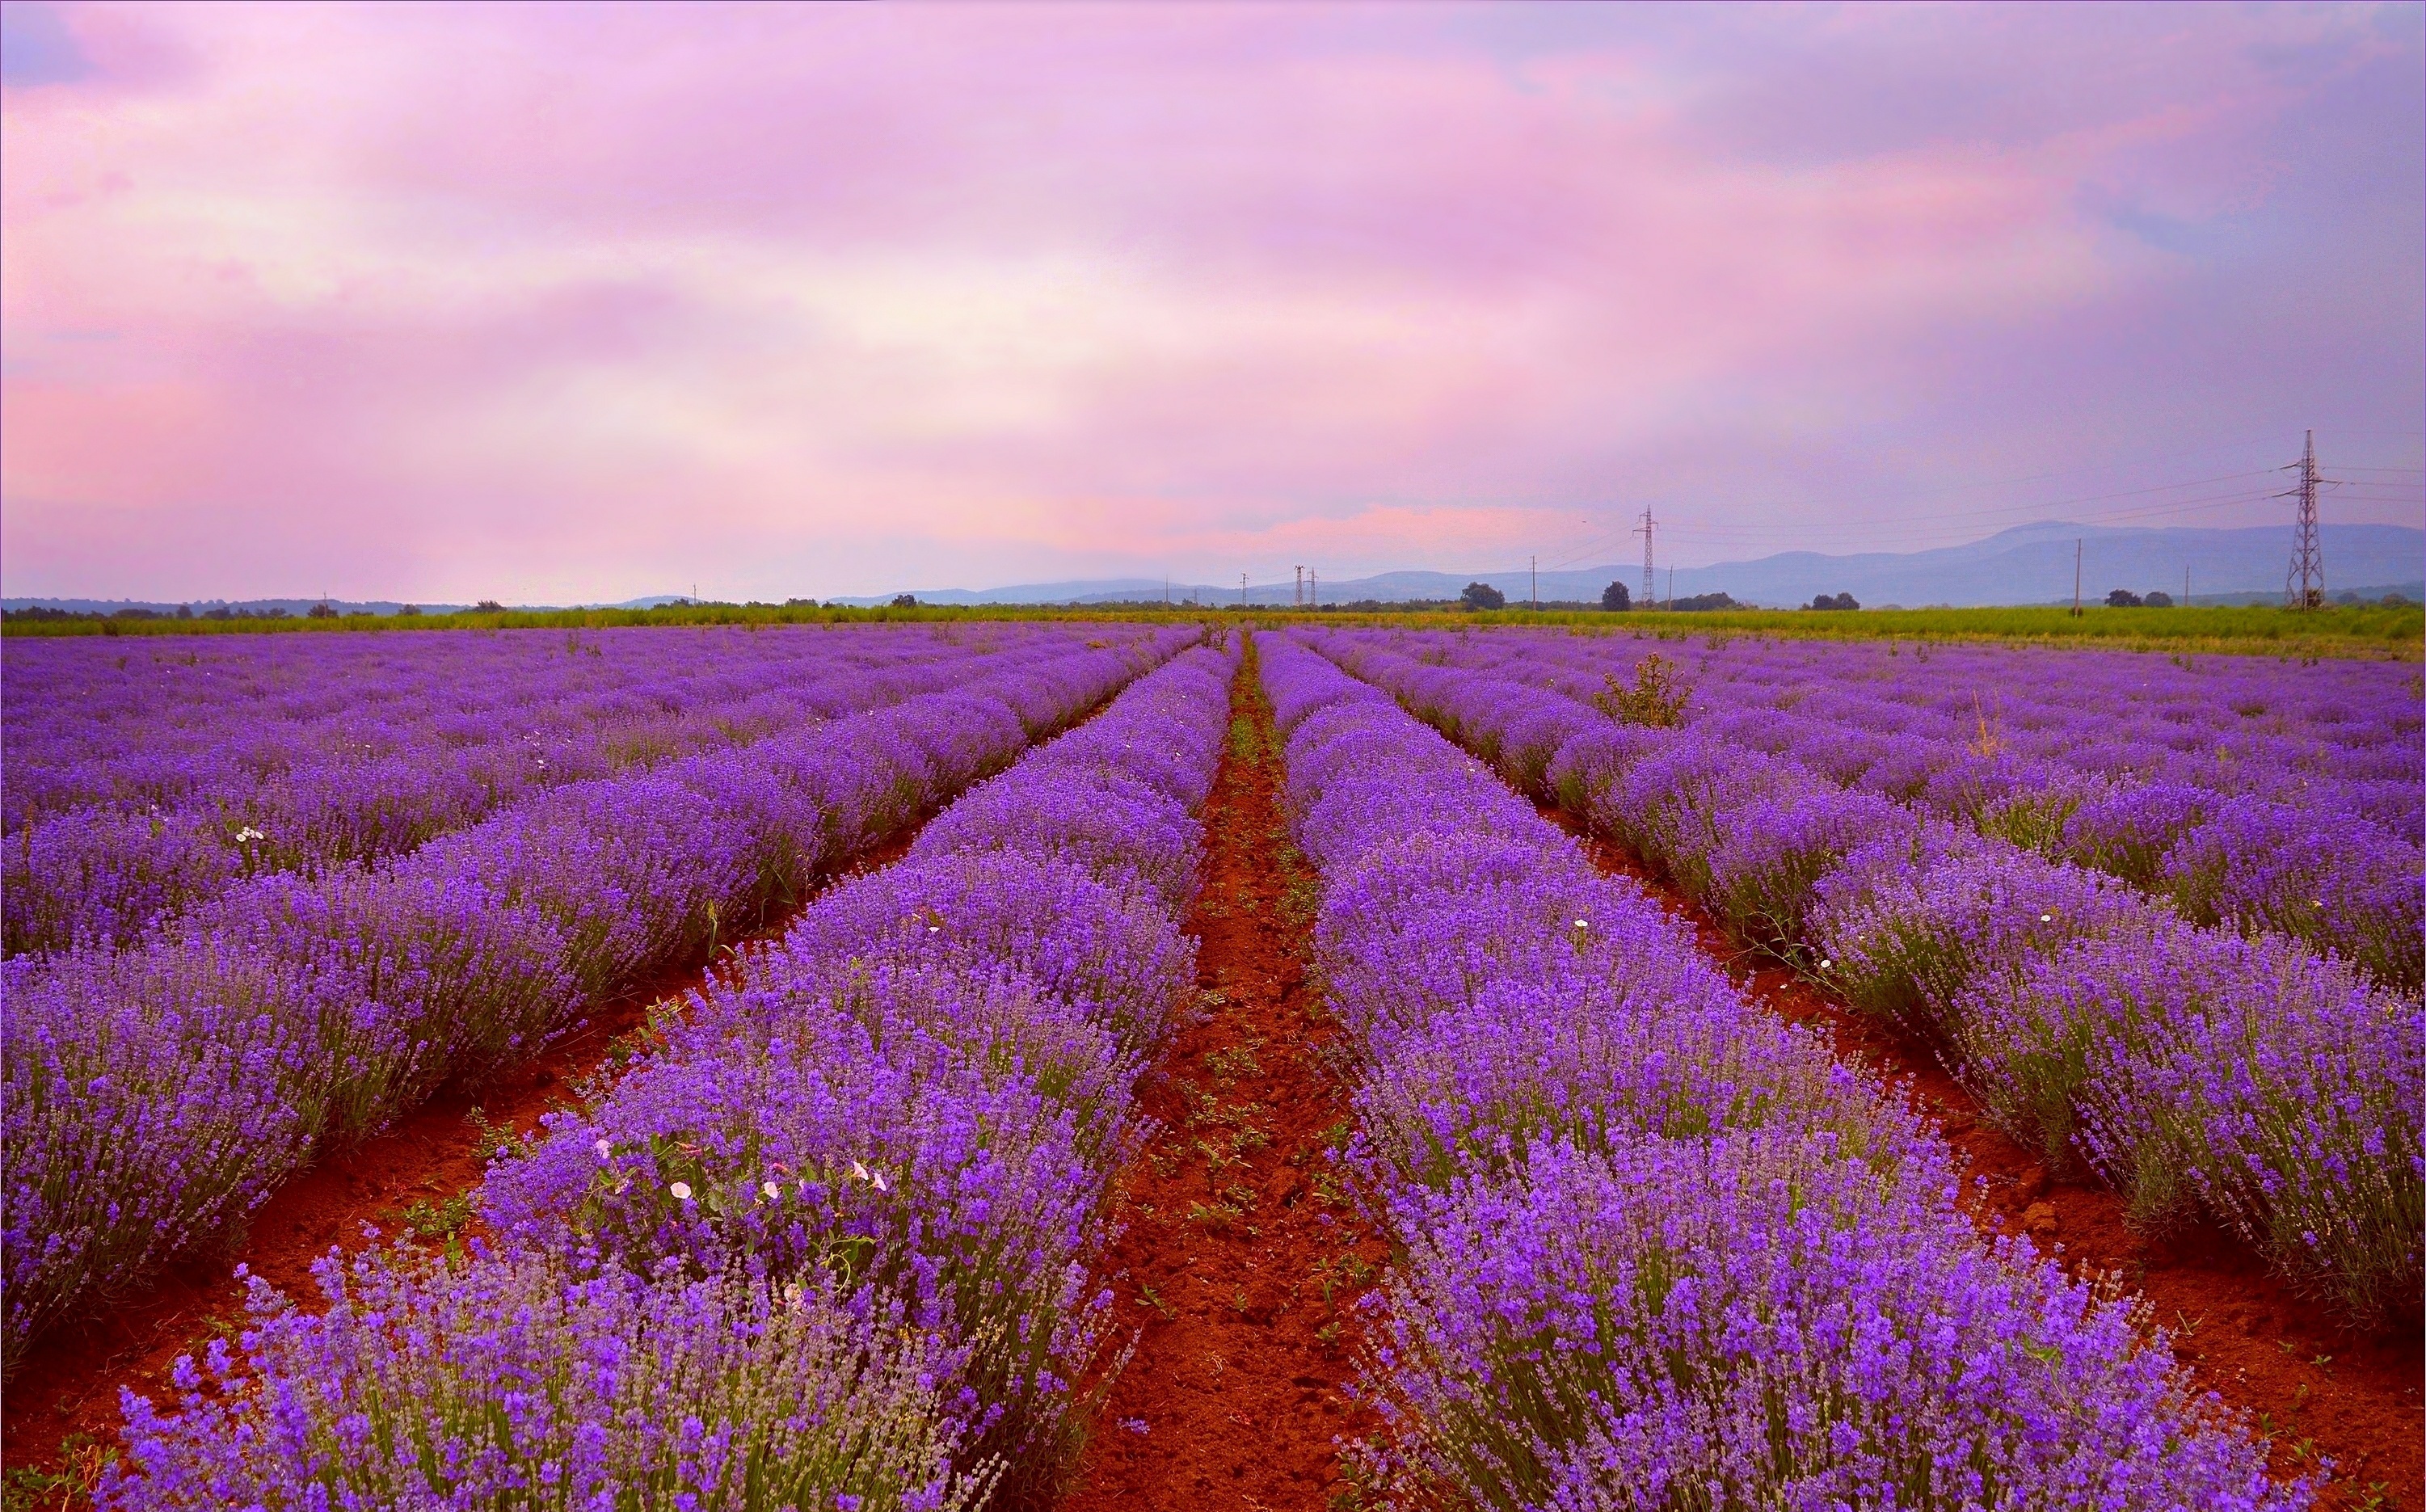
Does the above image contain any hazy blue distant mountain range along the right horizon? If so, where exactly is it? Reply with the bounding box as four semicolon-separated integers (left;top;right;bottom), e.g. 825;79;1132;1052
835;522;2426;607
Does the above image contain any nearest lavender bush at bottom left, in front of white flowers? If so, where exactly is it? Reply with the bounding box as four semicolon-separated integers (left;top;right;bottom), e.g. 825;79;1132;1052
95;1253;992;1512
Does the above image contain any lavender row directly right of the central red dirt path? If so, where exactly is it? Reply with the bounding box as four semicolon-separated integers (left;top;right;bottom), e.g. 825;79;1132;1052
1266;646;2310;1510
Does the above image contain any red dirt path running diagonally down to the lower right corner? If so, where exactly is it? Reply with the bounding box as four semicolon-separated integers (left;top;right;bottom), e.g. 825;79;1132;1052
1540;808;2426;1512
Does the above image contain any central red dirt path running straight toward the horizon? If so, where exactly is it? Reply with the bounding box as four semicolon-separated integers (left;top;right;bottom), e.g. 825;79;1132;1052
1060;655;1385;1512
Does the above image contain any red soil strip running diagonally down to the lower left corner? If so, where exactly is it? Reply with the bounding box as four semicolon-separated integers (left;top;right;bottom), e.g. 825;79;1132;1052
0;825;917;1507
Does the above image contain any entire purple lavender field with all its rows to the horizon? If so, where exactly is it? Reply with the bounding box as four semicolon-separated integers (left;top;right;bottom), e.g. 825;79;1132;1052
0;624;2426;1512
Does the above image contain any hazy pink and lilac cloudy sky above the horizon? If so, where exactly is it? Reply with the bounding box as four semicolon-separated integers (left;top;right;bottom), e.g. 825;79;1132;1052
0;0;2426;602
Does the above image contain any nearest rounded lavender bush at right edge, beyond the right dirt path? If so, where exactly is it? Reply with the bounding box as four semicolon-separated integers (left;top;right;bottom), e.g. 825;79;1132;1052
1953;922;2426;1318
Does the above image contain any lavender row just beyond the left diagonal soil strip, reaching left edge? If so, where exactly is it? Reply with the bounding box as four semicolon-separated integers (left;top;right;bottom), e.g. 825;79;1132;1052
0;631;1194;1364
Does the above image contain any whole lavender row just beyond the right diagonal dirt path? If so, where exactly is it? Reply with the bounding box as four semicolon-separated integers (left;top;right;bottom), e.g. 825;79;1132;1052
1322;636;2426;1318
